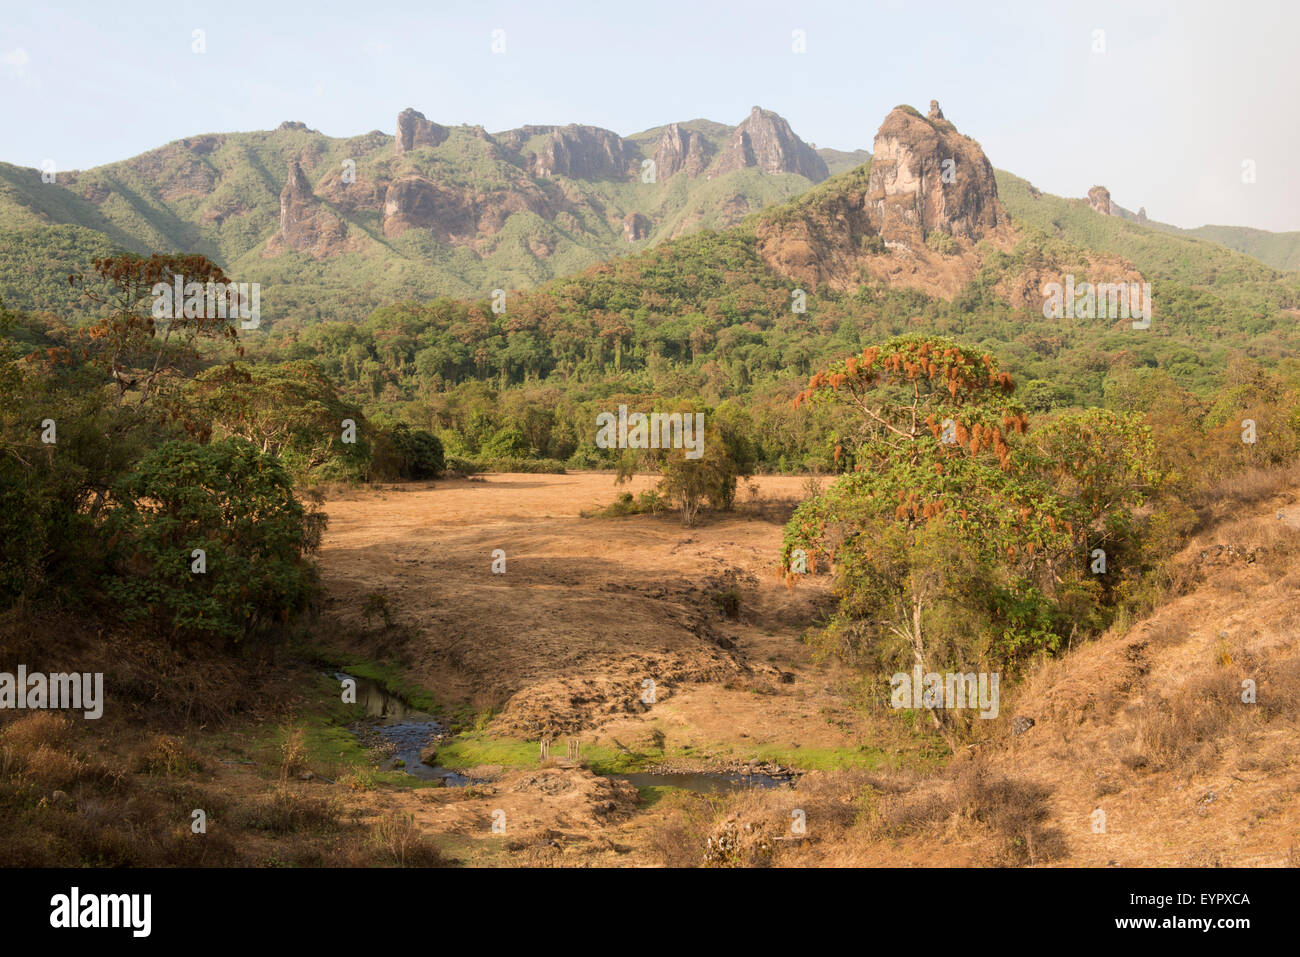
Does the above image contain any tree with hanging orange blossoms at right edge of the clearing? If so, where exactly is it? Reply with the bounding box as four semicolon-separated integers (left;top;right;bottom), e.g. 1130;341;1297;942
783;335;1159;727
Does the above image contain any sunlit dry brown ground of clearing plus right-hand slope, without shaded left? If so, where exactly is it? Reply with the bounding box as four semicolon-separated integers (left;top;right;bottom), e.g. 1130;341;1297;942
301;473;1300;866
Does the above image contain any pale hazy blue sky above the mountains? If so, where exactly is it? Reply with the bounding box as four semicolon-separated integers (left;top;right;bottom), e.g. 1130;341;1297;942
0;0;1300;230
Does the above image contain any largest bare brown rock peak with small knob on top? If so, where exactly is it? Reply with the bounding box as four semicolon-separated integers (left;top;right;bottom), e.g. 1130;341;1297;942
867;101;1006;247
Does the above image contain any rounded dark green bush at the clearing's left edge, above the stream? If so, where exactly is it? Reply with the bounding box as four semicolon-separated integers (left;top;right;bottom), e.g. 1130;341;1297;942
107;439;324;641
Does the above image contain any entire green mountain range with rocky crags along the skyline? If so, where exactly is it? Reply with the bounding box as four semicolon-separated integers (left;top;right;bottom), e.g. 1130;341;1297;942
0;101;1296;352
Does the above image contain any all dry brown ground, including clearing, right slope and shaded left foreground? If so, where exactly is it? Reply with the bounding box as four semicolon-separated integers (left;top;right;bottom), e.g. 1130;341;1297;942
0;472;1300;867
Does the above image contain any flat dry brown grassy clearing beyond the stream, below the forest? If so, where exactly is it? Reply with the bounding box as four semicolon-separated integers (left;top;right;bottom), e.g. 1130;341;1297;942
321;473;873;746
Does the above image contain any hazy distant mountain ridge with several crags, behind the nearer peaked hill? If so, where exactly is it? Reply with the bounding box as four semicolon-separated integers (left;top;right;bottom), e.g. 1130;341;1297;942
0;107;837;317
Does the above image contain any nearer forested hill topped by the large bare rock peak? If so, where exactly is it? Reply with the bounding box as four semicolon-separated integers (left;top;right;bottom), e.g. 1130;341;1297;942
197;103;1300;447
